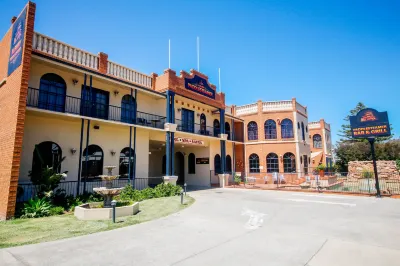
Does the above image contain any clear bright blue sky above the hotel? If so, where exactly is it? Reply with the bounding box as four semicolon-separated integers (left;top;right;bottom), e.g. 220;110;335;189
0;0;400;141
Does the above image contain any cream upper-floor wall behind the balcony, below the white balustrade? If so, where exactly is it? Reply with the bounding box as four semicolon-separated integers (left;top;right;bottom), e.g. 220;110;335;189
29;60;166;116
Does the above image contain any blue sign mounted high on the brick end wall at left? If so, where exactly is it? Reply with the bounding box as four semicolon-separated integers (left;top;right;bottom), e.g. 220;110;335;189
8;8;26;76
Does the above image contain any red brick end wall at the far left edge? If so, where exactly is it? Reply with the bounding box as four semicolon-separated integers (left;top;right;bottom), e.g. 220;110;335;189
0;2;36;219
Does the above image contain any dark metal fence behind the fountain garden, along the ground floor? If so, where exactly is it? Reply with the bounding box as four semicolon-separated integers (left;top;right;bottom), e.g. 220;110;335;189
17;177;163;202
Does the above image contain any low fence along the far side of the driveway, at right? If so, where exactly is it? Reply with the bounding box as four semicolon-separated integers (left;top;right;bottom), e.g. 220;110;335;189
217;171;400;195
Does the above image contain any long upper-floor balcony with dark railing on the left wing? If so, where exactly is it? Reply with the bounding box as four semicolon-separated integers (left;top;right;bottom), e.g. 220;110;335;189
26;88;166;129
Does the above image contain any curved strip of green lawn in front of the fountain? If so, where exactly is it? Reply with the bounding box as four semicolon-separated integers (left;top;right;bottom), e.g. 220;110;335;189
0;196;194;248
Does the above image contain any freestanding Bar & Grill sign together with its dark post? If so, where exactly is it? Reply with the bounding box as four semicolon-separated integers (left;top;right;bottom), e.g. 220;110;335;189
350;108;391;198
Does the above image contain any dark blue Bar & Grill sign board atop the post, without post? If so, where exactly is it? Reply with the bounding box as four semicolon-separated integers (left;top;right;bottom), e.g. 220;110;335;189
350;108;391;138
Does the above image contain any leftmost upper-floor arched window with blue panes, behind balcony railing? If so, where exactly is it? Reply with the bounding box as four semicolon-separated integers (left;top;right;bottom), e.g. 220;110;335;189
38;73;67;112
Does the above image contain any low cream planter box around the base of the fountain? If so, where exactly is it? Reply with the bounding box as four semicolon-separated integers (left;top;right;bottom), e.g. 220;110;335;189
74;202;139;220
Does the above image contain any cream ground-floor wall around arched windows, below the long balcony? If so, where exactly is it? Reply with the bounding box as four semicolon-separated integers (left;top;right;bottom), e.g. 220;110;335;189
20;111;149;181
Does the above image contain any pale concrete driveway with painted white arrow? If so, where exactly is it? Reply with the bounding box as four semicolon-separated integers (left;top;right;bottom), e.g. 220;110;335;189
0;189;400;266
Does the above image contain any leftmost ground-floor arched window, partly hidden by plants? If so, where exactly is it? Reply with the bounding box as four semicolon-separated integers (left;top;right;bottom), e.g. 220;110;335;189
31;141;62;178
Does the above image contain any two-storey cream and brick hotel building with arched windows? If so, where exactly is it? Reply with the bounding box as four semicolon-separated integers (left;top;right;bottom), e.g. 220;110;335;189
0;2;330;219
